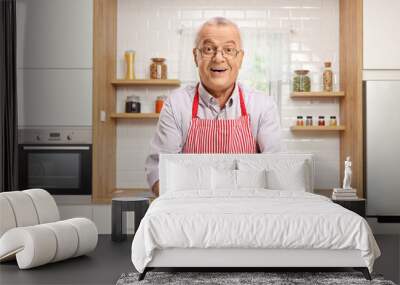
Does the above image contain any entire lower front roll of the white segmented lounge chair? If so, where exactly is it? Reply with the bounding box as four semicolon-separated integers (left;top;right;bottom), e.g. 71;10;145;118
0;218;98;269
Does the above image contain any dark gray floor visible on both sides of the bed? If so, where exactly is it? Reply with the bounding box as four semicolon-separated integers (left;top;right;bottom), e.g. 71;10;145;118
0;235;400;285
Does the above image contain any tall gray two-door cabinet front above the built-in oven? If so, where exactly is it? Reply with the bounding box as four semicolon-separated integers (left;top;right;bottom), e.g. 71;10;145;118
16;0;93;127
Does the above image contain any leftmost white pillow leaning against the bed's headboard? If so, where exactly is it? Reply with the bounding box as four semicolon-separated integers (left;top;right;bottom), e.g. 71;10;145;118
166;162;211;191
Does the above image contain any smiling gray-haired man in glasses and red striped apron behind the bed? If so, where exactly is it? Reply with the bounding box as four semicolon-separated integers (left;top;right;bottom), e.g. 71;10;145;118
146;18;282;196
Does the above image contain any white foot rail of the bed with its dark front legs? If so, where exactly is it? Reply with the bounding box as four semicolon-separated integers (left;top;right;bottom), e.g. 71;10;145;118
139;248;371;281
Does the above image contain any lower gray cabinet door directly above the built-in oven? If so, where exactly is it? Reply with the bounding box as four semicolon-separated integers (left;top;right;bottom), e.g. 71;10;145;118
17;69;92;127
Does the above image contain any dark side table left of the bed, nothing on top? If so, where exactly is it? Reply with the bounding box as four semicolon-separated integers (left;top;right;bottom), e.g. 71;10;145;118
111;197;150;241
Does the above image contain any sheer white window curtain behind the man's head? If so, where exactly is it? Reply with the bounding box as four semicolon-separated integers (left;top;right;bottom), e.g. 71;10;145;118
179;28;290;116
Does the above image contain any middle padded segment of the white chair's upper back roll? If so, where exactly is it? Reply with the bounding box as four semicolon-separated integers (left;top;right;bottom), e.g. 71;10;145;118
2;191;39;227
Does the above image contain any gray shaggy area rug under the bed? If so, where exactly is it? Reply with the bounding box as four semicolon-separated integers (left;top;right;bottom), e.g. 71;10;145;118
117;272;395;285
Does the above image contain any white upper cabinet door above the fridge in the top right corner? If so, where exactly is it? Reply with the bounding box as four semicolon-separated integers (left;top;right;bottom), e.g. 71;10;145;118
364;0;400;70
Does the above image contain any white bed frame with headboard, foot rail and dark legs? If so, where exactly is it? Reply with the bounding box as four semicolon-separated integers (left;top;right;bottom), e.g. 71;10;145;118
139;153;371;280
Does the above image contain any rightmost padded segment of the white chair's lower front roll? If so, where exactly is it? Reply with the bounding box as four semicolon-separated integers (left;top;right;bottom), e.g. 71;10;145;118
64;218;98;257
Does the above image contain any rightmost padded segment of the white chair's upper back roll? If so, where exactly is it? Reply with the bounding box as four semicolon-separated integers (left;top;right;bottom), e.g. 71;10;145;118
22;189;60;224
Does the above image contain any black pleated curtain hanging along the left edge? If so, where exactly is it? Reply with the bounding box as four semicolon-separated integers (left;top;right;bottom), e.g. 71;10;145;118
0;0;18;192
